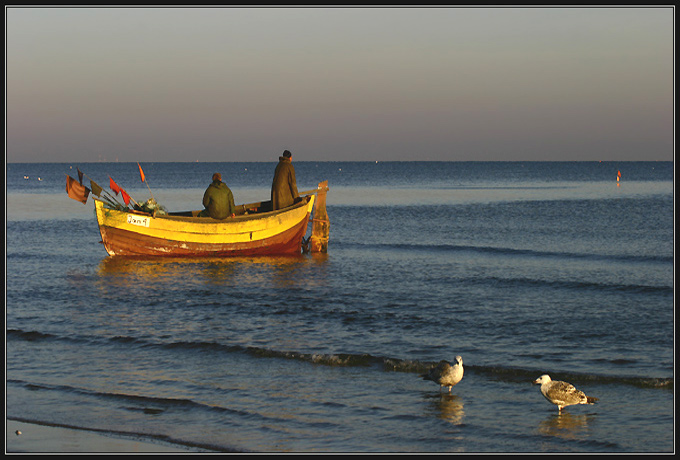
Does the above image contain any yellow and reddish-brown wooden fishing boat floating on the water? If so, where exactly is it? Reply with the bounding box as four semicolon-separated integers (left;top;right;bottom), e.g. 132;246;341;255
94;181;329;257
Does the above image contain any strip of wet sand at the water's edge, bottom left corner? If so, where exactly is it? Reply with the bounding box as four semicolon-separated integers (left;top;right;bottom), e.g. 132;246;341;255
5;420;196;453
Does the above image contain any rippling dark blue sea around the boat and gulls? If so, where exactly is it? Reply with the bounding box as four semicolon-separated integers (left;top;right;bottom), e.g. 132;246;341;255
5;161;675;454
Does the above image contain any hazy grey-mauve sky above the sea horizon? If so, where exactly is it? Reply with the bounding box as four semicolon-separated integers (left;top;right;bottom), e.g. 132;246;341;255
5;6;675;163
